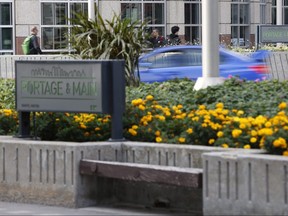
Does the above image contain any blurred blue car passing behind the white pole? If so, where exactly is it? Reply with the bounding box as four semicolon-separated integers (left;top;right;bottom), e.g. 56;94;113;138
139;45;269;83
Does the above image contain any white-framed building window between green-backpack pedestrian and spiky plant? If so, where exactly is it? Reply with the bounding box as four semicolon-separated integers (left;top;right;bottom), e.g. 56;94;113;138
41;0;88;52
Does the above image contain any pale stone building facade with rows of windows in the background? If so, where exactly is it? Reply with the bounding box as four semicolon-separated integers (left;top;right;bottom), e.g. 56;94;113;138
0;0;288;55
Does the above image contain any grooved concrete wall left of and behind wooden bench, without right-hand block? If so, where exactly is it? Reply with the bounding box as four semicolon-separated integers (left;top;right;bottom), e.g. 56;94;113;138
0;136;232;212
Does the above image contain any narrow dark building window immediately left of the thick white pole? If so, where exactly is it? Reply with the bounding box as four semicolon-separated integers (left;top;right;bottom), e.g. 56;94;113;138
184;0;202;44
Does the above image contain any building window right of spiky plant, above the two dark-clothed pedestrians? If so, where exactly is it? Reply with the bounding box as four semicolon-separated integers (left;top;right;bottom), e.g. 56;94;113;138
121;0;166;37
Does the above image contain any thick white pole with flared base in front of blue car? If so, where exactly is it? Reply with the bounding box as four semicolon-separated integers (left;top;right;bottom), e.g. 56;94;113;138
194;0;224;90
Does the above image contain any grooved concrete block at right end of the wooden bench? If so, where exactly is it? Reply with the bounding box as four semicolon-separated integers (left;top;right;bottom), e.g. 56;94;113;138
203;151;288;215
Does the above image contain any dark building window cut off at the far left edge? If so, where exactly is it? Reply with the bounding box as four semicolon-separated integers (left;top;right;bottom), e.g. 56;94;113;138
0;1;14;55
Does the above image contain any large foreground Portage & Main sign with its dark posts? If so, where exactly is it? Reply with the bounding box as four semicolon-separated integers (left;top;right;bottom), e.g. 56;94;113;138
15;60;125;140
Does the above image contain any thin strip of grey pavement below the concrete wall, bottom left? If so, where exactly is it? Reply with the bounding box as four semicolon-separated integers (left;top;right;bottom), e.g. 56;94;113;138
0;202;196;216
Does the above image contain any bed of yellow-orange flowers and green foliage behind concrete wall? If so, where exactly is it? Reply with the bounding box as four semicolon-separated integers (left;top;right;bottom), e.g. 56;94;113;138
0;78;288;155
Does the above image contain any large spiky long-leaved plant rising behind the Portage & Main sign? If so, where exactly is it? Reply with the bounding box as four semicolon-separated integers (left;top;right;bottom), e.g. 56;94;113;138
69;8;149;86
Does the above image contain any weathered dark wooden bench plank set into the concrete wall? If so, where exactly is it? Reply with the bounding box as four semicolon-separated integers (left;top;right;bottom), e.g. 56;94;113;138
80;159;202;188
